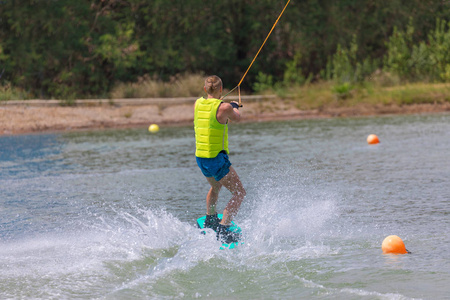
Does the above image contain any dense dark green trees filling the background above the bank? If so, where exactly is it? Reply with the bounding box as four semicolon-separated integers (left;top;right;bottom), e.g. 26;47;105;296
0;0;450;98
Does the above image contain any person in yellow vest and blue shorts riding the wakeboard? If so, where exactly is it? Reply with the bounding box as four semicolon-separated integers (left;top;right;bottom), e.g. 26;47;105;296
194;75;245;243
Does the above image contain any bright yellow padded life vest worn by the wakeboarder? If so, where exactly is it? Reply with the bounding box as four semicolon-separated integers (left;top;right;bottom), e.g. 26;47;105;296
194;97;229;158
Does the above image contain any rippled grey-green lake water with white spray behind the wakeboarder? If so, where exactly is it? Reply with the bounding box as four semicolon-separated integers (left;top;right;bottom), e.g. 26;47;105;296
0;114;450;299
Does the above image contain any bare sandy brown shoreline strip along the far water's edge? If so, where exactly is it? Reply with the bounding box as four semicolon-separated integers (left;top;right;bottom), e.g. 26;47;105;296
0;100;450;135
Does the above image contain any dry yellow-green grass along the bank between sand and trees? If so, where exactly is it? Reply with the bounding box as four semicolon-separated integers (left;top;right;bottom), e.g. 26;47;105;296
0;75;450;110
